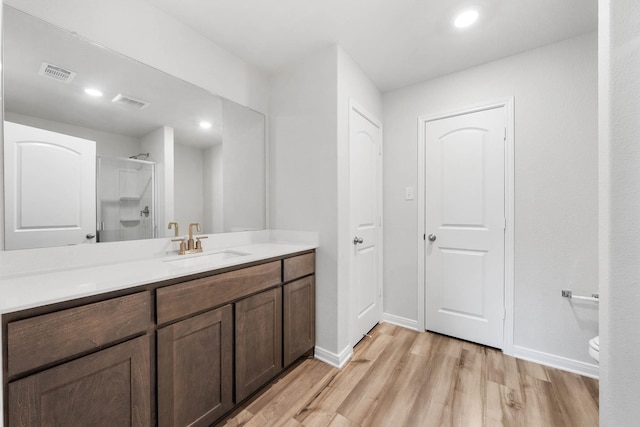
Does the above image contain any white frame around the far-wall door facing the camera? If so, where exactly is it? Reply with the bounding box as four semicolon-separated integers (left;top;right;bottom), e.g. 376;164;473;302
416;97;515;355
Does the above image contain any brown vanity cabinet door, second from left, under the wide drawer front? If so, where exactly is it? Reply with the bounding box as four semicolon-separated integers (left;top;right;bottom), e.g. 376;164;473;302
158;305;233;427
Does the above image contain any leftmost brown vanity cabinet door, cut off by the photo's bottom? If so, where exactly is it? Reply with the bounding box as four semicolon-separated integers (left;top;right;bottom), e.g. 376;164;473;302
8;336;151;427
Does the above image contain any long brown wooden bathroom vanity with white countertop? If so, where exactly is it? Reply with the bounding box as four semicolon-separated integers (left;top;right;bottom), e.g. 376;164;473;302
2;239;315;426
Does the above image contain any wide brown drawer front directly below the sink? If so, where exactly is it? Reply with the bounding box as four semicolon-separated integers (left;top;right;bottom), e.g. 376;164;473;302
156;261;282;325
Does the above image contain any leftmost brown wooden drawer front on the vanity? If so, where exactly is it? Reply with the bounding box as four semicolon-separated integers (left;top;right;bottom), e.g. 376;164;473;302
7;291;151;376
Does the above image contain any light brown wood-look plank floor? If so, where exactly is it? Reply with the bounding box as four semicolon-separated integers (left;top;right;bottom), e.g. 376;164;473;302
220;323;598;427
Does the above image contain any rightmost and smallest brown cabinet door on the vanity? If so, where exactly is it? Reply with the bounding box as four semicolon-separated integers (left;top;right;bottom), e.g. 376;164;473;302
283;276;316;367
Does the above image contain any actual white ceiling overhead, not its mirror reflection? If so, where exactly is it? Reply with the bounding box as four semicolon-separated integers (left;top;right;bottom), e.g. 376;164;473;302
142;0;598;91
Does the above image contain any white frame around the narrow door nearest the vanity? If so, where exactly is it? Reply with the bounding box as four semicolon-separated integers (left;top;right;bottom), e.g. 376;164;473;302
347;98;384;348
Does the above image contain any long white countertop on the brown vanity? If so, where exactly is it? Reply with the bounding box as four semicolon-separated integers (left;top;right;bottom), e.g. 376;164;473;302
0;234;317;313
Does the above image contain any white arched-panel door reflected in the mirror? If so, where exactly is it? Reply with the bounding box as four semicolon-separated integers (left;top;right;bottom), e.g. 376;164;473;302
4;122;96;249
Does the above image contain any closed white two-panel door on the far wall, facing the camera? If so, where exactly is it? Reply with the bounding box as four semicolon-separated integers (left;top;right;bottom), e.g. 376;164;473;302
425;107;506;348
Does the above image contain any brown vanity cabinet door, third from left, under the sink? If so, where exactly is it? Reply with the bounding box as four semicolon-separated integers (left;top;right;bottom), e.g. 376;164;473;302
236;288;282;402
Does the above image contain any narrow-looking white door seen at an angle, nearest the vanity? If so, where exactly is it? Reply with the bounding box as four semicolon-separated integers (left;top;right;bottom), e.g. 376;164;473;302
349;105;382;345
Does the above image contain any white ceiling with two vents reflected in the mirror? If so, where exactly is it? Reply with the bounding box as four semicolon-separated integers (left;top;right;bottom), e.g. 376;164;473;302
3;5;223;148
